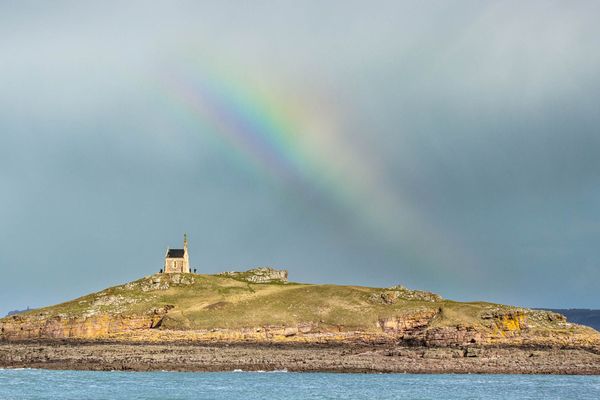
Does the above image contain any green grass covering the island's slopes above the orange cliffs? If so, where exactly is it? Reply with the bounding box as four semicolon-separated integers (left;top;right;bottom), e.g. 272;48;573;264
7;274;592;336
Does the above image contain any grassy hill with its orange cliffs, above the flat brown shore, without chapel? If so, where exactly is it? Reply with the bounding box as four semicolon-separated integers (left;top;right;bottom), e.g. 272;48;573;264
0;270;599;345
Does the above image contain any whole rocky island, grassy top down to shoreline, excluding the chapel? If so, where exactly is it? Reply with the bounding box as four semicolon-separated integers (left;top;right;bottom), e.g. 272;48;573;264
0;268;600;374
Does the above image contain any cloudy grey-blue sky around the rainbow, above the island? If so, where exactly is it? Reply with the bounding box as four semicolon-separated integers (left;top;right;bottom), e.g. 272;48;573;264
0;1;600;314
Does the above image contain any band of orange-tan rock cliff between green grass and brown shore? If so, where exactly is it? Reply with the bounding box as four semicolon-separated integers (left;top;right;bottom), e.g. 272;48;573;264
0;310;600;347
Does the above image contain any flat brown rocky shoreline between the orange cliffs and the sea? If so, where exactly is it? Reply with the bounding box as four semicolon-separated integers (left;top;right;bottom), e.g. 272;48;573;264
0;341;600;375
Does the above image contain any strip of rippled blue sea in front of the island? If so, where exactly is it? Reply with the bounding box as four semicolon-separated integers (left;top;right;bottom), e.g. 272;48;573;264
0;369;600;400
